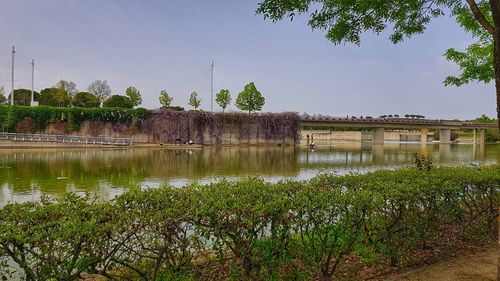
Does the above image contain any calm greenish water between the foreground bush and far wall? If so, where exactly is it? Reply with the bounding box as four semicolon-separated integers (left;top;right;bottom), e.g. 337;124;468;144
0;142;500;205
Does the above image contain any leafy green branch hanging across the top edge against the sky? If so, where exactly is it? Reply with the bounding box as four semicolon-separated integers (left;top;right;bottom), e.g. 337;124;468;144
257;0;461;45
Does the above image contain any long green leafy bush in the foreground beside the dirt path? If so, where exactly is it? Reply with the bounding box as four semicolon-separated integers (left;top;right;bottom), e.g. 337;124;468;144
0;166;500;280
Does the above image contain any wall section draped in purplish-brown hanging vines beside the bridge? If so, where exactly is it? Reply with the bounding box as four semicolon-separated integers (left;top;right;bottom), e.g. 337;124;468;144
141;110;300;144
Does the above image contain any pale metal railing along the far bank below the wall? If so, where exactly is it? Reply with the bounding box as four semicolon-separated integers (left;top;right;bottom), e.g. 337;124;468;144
0;132;132;146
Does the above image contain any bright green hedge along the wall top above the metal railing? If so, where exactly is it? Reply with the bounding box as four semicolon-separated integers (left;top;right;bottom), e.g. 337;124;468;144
0;105;151;132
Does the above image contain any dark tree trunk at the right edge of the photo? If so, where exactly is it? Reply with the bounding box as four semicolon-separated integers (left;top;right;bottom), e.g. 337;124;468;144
490;0;500;131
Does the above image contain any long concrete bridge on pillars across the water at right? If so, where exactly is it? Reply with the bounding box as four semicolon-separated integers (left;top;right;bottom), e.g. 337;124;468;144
301;115;497;144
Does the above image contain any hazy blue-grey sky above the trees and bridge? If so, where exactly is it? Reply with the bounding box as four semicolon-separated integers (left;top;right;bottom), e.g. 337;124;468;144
0;0;496;119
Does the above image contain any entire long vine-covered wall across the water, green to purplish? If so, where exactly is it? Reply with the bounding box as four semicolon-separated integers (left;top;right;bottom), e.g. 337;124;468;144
0;106;300;144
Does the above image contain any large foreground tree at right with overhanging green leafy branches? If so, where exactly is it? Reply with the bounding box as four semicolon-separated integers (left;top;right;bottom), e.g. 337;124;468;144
257;0;500;130
